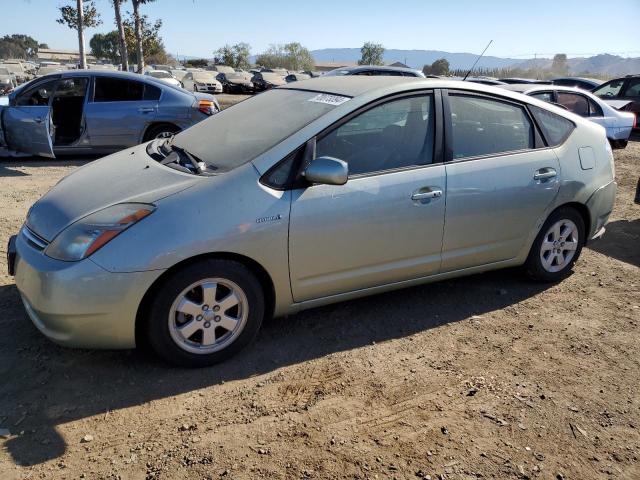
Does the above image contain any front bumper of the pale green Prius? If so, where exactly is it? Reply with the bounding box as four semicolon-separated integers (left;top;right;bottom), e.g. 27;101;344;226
14;229;162;348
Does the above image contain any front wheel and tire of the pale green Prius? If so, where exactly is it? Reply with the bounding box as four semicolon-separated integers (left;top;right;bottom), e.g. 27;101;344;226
146;260;265;367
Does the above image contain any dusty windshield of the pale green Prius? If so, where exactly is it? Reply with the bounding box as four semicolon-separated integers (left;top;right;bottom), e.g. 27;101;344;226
173;89;348;171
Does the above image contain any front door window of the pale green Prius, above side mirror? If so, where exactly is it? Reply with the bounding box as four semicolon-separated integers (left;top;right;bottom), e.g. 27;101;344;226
316;95;434;175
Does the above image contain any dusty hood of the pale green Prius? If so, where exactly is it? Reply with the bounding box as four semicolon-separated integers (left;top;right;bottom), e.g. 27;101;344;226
26;144;201;241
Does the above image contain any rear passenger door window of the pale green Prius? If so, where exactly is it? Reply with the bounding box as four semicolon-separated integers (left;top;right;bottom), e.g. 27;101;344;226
449;95;534;159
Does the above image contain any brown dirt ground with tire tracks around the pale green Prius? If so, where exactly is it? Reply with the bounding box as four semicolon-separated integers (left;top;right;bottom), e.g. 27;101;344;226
0;142;640;480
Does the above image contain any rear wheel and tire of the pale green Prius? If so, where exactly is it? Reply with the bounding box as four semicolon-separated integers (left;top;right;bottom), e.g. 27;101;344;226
525;207;585;283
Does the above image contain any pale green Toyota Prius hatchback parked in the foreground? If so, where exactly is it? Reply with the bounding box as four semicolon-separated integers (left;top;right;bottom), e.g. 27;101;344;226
8;76;616;366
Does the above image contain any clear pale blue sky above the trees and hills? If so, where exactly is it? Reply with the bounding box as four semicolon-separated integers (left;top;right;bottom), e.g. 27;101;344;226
5;0;640;58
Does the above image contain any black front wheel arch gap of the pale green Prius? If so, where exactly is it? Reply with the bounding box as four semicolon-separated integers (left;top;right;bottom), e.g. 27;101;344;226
135;252;276;347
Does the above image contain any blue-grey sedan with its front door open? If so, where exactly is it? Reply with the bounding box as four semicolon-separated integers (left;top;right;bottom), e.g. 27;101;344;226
0;70;220;157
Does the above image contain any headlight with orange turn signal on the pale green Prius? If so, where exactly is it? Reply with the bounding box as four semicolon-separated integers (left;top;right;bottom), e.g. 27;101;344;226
44;203;156;262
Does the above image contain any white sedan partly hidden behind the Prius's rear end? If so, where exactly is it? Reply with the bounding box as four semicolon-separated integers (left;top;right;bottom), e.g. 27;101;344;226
503;84;636;148
